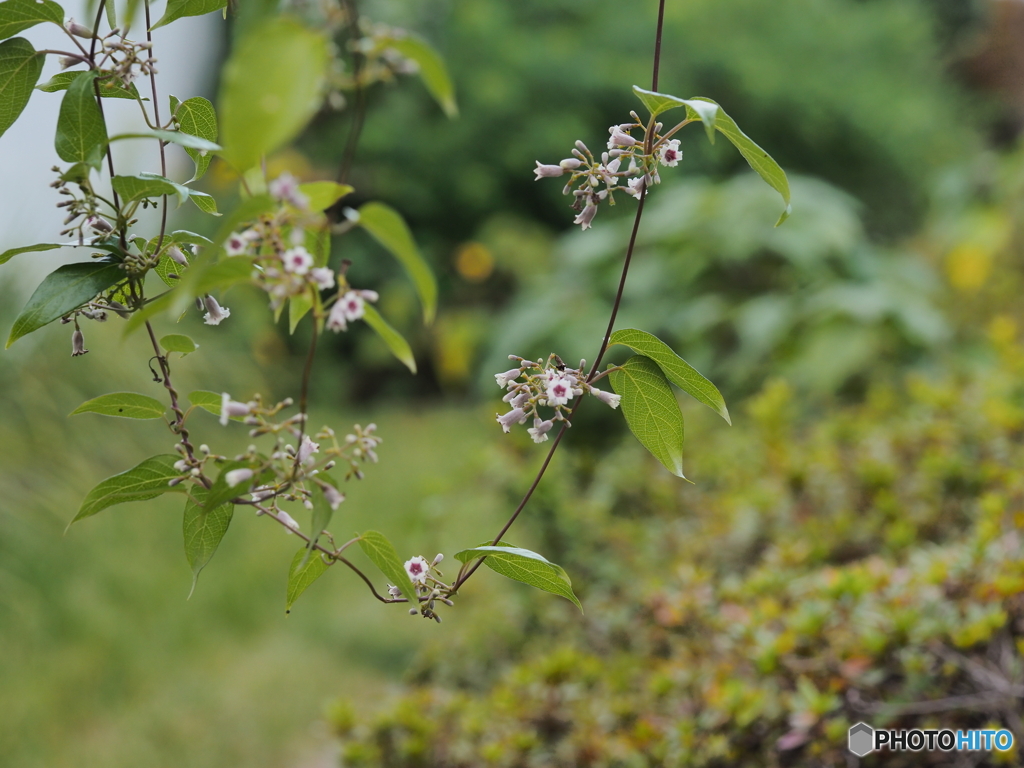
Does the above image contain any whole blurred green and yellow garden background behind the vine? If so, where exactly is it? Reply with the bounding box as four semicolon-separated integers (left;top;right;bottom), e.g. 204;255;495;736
6;0;1024;768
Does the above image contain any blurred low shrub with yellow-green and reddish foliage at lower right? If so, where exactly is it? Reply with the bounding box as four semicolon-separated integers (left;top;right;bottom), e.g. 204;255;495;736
334;328;1024;768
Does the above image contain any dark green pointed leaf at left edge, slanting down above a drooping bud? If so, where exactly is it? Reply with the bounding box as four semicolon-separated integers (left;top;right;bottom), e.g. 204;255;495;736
7;260;125;347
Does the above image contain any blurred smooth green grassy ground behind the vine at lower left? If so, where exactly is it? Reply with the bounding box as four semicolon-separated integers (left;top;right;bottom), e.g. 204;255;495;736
0;317;520;768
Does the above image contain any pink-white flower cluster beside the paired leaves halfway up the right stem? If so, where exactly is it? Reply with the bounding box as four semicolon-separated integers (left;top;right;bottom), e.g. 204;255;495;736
495;354;621;442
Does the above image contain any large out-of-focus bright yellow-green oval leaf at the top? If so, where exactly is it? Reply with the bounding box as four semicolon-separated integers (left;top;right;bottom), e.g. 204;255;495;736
219;17;330;172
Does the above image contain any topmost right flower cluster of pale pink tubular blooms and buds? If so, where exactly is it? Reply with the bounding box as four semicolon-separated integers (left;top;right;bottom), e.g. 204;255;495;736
534;112;683;229
